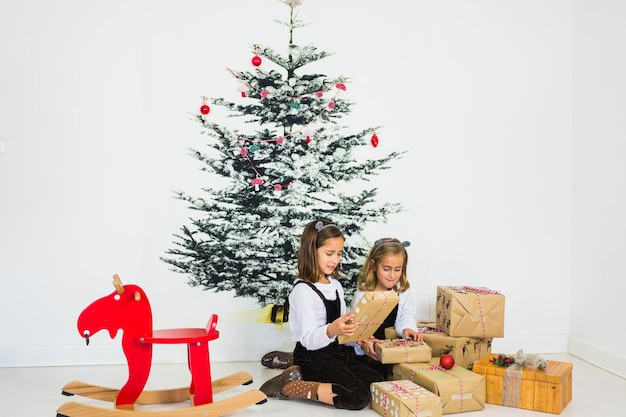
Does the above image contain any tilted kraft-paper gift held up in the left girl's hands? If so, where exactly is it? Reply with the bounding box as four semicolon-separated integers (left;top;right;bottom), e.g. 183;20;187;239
337;291;400;344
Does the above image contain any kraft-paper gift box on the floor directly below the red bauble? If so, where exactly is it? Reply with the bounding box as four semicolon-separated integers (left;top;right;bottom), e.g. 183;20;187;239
393;358;485;414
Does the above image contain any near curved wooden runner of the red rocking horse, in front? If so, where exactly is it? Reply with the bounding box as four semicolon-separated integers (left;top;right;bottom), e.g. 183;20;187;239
57;390;267;417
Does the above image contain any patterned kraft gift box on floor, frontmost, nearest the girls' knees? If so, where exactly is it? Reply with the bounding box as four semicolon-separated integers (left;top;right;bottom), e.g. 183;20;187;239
370;380;442;417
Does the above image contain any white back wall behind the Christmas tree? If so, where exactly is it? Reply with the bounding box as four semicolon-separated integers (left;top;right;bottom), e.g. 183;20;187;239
0;0;624;376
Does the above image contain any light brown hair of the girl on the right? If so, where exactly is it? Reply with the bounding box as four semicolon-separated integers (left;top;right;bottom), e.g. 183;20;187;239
356;238;410;292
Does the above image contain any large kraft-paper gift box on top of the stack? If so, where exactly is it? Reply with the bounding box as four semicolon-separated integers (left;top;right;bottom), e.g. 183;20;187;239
435;286;504;338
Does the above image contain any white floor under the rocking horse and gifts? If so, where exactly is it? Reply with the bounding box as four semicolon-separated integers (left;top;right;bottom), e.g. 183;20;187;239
0;354;626;417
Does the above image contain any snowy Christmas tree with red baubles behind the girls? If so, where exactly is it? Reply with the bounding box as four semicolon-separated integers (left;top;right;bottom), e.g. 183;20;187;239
162;0;403;320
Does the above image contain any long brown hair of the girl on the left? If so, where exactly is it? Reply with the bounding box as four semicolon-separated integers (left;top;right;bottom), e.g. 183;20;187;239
297;219;346;282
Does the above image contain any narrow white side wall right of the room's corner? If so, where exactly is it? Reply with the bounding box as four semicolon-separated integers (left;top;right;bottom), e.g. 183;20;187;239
569;0;626;376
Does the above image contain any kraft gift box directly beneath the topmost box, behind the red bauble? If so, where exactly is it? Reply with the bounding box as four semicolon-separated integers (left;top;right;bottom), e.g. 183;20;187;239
417;321;493;369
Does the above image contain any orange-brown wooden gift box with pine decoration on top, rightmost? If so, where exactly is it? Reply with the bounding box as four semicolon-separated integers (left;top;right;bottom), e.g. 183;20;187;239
473;354;573;414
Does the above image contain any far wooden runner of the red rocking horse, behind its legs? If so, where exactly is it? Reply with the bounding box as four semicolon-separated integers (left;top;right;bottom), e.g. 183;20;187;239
62;372;252;404
